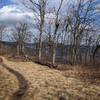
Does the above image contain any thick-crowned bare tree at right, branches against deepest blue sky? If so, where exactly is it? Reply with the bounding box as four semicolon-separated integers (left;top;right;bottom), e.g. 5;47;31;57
65;0;94;64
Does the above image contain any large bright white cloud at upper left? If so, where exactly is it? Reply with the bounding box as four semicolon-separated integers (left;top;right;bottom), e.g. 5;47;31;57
0;5;34;24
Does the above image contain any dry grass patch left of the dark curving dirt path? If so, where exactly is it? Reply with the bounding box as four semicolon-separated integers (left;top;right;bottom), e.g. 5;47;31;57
0;65;18;100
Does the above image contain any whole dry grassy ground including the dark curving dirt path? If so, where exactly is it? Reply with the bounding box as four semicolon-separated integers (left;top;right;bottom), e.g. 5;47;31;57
0;57;100;100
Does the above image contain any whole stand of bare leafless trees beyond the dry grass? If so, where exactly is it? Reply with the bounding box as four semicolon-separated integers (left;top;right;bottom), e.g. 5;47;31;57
0;0;100;65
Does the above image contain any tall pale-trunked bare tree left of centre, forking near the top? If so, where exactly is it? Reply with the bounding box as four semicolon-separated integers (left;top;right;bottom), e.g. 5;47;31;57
23;0;47;60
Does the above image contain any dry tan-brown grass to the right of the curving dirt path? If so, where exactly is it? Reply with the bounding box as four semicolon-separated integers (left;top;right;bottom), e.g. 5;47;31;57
0;58;100;100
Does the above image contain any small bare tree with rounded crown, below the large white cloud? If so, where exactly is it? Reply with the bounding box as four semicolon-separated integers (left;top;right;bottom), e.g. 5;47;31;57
12;23;31;55
